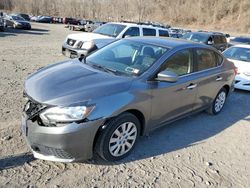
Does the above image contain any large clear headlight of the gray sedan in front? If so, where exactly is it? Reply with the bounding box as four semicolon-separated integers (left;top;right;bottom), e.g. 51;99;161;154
40;106;94;125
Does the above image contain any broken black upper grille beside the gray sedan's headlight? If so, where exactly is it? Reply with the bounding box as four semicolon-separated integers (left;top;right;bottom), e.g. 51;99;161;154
23;99;46;119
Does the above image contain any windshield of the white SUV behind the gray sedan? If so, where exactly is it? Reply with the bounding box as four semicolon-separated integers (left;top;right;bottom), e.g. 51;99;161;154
93;24;126;37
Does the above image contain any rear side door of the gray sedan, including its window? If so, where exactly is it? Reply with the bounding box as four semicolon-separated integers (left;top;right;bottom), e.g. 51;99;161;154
194;48;226;110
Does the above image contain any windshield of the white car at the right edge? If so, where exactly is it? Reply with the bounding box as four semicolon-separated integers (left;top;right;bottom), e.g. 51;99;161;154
223;47;250;62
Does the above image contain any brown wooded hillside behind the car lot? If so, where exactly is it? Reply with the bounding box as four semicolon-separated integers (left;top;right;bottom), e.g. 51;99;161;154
0;0;250;34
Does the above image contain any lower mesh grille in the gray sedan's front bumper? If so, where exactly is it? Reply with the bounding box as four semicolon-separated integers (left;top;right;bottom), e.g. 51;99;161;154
31;145;73;159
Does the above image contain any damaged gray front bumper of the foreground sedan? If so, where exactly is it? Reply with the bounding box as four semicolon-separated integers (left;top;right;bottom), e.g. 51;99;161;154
22;117;104;162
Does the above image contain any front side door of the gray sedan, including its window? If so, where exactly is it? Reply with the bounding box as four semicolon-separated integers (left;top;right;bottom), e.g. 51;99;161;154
151;49;197;128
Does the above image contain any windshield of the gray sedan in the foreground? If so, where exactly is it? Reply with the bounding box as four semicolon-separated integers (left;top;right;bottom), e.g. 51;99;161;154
86;40;168;76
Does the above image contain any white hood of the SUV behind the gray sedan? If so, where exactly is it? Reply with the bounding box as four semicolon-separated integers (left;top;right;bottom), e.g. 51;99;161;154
67;33;112;42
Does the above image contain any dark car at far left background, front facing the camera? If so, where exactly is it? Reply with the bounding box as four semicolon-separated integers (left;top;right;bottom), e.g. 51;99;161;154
5;14;31;29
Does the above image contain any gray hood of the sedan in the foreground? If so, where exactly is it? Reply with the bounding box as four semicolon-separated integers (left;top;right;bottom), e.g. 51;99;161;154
24;59;132;106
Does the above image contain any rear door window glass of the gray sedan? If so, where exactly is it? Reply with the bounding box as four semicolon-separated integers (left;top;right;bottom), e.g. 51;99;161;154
195;49;217;71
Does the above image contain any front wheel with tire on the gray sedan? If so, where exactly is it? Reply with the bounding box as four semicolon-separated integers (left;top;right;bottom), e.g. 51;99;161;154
95;113;140;161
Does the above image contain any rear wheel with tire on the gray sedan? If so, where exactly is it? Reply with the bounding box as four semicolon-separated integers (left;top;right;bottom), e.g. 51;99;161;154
207;87;227;115
